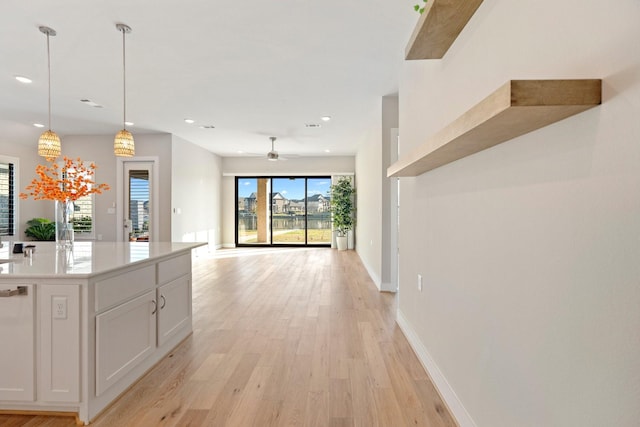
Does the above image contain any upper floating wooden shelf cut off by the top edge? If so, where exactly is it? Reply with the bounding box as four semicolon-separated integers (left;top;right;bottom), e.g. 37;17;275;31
405;0;482;59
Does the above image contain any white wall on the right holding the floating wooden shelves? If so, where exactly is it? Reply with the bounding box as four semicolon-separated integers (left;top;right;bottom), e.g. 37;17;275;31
399;0;640;427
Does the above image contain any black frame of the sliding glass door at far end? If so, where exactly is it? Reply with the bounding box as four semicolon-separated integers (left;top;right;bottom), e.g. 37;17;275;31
234;175;333;247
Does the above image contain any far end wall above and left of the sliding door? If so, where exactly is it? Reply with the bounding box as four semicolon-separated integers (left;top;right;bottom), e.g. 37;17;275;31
222;156;355;247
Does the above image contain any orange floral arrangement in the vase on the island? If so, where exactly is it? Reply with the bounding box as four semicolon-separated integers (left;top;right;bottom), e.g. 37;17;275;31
20;157;109;202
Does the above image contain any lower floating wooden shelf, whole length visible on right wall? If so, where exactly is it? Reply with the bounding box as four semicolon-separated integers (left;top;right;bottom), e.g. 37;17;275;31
387;80;602;177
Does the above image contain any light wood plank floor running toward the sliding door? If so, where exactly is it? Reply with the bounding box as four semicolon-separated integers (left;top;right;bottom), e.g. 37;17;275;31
0;248;456;427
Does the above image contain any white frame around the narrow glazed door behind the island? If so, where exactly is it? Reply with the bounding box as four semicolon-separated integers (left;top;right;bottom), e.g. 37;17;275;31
116;156;160;242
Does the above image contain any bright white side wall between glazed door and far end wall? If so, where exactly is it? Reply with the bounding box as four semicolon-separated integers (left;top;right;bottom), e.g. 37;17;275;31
171;136;222;250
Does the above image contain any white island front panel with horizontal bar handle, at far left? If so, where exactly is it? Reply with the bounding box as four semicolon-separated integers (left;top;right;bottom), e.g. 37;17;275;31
0;285;35;401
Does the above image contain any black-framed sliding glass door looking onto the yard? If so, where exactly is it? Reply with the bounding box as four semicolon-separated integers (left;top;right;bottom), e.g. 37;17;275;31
236;177;331;246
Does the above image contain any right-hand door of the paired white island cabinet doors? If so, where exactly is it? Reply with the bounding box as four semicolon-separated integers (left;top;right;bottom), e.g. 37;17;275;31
158;276;191;347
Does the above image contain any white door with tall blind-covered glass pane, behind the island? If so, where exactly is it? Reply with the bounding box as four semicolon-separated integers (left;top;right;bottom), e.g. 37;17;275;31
123;161;155;242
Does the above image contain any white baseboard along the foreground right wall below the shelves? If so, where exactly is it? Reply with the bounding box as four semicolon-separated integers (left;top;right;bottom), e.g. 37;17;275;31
396;310;477;427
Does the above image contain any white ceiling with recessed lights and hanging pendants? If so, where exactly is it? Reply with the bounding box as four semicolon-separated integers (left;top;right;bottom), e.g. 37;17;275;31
0;0;418;156
